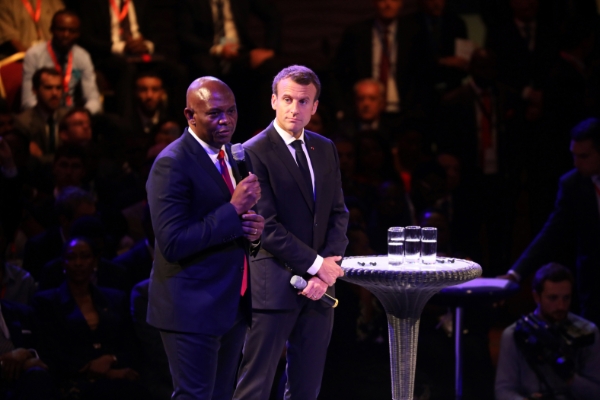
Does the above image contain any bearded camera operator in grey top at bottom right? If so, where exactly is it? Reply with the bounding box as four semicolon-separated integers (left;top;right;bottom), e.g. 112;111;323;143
496;263;600;400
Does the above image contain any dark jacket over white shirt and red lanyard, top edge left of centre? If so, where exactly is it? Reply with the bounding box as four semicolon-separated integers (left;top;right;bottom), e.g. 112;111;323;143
77;0;150;59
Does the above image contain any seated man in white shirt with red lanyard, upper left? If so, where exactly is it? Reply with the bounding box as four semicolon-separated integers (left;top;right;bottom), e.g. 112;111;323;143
21;10;101;113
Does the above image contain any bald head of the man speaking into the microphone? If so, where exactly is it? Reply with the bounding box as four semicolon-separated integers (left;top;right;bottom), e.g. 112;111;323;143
183;76;238;148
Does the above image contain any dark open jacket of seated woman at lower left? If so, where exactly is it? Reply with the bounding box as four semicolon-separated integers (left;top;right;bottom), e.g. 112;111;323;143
33;282;132;378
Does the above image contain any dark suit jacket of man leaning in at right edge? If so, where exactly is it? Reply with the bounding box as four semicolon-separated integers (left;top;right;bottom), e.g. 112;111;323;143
512;169;600;324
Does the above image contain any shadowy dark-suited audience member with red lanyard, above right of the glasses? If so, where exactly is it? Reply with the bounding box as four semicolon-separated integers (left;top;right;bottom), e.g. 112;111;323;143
438;49;524;275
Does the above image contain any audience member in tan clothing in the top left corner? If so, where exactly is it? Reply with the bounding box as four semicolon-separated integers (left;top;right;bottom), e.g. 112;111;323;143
0;0;64;59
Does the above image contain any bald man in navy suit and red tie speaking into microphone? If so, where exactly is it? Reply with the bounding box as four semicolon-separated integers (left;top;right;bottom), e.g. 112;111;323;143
147;77;264;399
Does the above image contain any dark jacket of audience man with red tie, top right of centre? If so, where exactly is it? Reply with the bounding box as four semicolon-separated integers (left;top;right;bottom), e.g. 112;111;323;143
334;15;427;110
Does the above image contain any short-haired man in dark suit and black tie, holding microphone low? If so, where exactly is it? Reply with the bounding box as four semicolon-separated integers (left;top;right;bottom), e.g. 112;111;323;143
234;65;349;400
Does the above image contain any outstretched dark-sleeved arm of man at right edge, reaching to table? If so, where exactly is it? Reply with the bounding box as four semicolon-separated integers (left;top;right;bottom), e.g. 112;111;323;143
511;175;578;279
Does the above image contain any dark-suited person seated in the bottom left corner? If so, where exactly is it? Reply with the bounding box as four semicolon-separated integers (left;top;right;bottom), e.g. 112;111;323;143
0;300;58;400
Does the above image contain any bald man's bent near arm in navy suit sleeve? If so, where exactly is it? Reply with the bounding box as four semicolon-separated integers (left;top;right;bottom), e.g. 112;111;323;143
148;156;260;262
